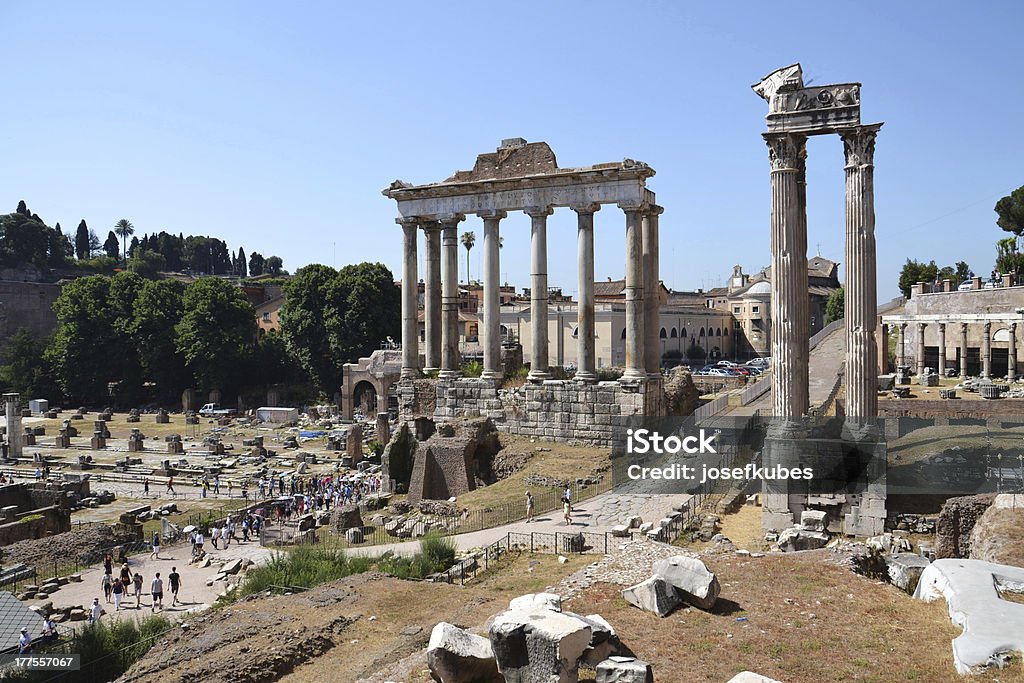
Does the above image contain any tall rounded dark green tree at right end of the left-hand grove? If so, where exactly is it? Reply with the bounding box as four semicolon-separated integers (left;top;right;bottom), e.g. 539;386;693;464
174;278;256;392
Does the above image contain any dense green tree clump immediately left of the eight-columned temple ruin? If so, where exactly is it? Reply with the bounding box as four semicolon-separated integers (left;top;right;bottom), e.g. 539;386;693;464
281;263;401;395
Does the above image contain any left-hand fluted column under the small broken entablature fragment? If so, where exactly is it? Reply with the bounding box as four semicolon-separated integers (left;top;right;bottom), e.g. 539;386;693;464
764;133;810;418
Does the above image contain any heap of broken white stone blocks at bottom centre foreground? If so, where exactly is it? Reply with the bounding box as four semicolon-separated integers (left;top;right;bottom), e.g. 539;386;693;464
427;593;654;683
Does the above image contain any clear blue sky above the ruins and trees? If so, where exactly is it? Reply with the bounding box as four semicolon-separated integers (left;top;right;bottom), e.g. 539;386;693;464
0;0;1024;300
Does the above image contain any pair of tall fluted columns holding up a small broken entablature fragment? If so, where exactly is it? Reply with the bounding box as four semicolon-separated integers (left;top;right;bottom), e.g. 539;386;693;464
764;124;881;420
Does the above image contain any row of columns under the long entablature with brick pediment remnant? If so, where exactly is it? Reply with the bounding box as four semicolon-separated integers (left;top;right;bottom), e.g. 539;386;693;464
396;204;663;382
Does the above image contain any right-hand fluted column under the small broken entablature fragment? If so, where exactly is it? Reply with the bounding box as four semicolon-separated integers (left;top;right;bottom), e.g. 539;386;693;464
839;126;880;424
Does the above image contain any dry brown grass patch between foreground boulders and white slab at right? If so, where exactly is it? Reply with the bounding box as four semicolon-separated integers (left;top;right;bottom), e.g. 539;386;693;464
567;551;1024;683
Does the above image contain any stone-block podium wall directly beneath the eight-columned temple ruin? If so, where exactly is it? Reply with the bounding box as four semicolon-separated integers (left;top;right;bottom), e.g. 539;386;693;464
398;378;666;447
